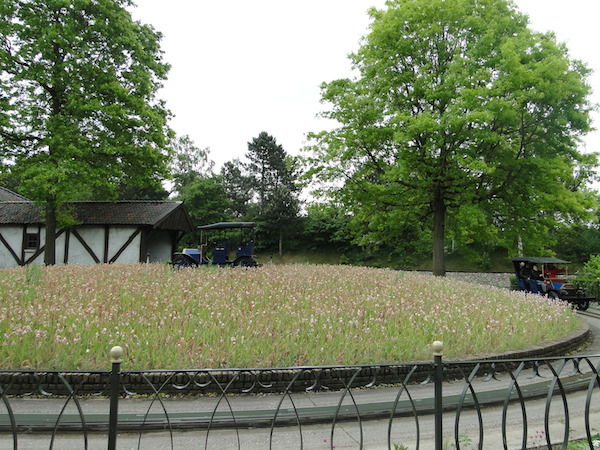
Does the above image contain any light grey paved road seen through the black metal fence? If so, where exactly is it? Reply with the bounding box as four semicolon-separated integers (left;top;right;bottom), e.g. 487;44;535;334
0;308;600;450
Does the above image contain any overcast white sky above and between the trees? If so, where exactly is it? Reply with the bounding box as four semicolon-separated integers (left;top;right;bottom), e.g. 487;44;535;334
132;0;600;172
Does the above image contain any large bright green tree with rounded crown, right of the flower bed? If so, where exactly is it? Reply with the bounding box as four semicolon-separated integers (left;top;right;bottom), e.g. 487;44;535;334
309;0;595;275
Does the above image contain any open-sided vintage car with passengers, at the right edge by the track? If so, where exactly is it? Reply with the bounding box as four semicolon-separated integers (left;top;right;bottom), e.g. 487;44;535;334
512;256;598;311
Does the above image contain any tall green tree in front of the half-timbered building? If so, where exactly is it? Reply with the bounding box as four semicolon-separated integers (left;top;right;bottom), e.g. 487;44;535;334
0;0;170;264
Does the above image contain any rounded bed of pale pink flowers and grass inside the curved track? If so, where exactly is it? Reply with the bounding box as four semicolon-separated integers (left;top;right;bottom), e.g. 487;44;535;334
0;264;578;370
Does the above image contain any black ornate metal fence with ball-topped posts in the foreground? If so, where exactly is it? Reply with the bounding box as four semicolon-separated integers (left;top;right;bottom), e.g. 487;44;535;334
0;346;600;449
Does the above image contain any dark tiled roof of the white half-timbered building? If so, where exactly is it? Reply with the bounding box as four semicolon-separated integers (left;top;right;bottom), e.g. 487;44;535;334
0;200;193;231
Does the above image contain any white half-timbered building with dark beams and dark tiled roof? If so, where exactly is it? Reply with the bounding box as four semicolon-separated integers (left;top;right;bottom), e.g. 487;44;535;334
0;189;192;267
